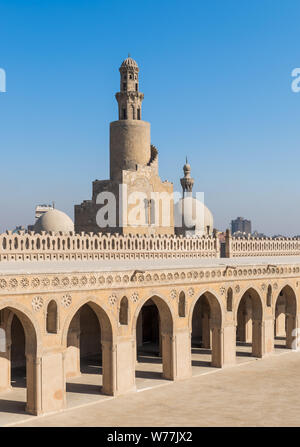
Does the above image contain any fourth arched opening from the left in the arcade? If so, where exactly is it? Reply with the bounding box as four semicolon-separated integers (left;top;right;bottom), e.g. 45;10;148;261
191;292;222;372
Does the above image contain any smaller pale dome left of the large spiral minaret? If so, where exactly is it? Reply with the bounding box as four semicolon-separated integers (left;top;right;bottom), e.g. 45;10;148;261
34;209;74;233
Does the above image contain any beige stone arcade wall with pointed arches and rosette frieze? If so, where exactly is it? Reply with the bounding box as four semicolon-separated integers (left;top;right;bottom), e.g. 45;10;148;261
0;248;300;414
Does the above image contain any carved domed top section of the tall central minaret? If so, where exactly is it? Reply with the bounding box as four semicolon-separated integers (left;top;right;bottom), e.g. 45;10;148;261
116;55;144;120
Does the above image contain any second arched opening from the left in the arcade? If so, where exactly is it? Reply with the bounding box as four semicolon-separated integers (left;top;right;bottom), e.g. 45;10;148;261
65;302;112;406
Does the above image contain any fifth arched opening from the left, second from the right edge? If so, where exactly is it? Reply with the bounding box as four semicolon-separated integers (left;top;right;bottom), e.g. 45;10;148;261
236;288;263;362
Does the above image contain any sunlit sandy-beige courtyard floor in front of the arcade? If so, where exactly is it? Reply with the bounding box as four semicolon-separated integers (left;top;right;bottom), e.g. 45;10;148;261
0;340;300;427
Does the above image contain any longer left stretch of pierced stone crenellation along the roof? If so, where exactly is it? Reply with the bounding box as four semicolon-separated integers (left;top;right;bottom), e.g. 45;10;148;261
0;231;220;261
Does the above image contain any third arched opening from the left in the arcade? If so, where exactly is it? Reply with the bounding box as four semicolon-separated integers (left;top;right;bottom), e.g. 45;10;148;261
136;296;173;388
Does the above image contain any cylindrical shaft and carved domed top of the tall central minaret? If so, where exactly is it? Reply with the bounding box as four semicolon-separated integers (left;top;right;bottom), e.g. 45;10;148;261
110;57;151;182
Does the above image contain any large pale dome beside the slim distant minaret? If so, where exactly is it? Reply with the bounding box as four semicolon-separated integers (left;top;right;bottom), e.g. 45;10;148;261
174;196;214;235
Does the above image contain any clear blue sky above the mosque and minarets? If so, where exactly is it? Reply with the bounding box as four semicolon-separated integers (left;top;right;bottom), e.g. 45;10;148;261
0;0;300;235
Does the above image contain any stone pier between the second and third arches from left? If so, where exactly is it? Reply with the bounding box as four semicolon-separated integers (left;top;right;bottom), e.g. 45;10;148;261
102;337;136;396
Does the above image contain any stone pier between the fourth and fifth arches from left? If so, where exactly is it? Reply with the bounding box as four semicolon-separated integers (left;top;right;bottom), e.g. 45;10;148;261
211;321;236;368
